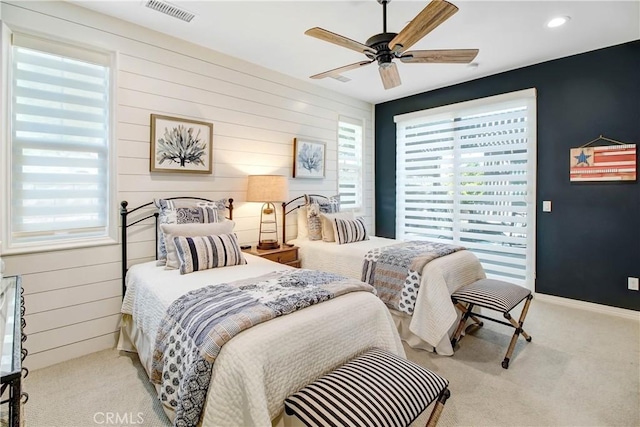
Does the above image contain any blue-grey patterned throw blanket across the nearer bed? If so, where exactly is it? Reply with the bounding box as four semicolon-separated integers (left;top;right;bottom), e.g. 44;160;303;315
151;270;375;426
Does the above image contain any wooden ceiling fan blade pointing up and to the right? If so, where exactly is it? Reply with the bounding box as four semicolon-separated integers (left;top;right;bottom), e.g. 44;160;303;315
389;0;458;53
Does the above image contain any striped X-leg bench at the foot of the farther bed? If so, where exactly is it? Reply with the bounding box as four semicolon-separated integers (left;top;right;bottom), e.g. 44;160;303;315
451;279;533;369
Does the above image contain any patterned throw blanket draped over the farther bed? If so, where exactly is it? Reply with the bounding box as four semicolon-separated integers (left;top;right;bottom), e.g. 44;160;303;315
362;241;465;314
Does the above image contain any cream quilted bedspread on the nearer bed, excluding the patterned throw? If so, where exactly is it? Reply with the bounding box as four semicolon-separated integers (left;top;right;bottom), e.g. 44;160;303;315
118;254;404;425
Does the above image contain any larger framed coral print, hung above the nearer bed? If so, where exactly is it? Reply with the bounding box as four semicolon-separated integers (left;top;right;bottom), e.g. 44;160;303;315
150;114;213;174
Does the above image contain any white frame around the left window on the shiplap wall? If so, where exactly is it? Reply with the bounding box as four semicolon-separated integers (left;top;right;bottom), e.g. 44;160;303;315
0;30;118;255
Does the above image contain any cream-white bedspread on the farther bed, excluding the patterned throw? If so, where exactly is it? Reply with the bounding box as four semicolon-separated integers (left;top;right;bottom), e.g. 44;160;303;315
289;237;486;356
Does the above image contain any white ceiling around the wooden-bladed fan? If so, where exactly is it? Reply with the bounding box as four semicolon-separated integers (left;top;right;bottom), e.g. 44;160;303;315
73;0;640;103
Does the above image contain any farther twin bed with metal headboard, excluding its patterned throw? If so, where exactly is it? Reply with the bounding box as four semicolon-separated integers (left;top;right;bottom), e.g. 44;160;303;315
282;194;486;356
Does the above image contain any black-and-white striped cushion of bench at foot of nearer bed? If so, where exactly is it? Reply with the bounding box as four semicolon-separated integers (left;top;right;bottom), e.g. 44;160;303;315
284;349;449;427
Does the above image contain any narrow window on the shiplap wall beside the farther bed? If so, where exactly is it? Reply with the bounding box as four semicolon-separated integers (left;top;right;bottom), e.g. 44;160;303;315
338;117;364;211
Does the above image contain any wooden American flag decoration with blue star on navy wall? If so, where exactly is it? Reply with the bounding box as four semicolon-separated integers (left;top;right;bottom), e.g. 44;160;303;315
569;141;638;181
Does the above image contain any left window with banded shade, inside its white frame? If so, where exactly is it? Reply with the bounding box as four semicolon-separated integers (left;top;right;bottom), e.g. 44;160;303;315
8;34;114;254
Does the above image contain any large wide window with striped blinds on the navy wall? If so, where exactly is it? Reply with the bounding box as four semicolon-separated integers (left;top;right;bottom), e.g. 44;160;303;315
395;89;536;289
